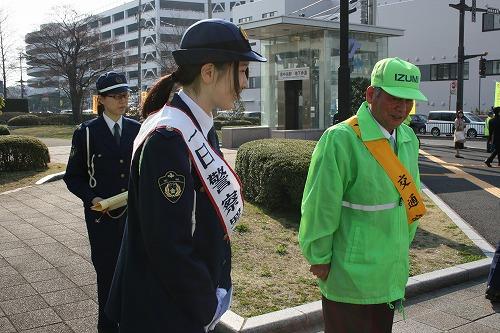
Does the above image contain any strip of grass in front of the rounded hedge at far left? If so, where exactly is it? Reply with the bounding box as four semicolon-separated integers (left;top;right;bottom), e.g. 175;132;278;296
0;163;66;193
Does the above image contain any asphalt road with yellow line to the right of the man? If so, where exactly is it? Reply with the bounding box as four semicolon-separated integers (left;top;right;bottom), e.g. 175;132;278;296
420;138;500;245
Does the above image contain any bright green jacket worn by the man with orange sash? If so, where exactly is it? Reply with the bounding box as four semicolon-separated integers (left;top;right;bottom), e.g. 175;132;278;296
299;102;420;304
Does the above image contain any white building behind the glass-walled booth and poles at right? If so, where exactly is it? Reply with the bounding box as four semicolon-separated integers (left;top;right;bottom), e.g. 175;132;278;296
233;0;500;114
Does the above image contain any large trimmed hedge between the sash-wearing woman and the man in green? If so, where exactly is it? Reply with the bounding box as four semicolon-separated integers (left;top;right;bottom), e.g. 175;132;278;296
236;139;316;213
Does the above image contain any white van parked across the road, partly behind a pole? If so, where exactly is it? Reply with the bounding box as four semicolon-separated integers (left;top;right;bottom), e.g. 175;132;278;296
426;110;484;138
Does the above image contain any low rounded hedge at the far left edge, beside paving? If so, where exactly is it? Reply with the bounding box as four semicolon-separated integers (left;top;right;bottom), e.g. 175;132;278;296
0;135;50;171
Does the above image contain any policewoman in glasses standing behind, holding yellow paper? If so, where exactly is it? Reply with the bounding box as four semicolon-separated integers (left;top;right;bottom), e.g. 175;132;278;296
64;72;140;333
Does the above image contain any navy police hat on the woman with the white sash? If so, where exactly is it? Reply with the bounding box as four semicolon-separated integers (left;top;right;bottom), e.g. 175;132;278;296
172;19;267;65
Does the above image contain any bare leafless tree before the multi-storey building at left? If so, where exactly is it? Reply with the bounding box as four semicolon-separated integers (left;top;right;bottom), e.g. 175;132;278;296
26;7;124;123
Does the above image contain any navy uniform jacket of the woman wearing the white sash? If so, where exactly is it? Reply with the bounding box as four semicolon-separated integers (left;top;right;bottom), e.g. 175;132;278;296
106;95;231;333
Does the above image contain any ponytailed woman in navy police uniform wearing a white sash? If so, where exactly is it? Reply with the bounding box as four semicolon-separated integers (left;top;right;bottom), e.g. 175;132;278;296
107;19;265;333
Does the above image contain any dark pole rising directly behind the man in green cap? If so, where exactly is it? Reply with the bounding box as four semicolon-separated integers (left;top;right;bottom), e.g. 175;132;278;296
337;1;351;121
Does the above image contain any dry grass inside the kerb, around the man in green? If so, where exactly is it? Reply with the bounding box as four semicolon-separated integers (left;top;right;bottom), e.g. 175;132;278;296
231;195;484;317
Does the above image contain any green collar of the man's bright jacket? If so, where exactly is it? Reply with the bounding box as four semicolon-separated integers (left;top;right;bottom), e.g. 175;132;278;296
357;101;411;142
